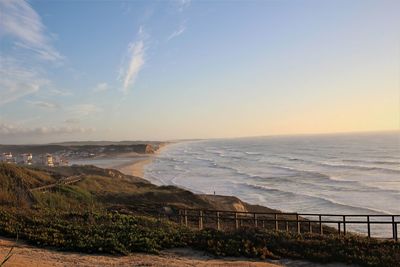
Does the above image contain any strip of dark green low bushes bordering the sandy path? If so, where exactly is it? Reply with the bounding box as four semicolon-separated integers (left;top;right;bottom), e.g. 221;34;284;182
0;210;400;266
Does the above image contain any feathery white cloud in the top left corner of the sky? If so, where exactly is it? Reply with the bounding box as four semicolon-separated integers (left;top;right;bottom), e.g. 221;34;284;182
0;0;63;61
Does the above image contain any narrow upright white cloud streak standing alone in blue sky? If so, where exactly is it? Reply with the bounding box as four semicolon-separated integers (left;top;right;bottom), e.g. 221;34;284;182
120;27;145;93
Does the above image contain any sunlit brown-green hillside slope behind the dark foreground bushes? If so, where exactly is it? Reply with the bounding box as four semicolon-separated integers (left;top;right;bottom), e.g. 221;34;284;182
0;163;251;214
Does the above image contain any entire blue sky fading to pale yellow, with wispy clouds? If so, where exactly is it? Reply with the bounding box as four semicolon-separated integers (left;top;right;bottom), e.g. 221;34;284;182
0;0;400;144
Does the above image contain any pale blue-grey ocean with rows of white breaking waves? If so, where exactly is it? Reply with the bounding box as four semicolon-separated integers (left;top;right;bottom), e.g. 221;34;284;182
144;132;400;235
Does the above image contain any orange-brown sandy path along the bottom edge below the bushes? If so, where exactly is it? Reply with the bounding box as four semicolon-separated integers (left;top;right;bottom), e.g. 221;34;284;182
0;238;280;267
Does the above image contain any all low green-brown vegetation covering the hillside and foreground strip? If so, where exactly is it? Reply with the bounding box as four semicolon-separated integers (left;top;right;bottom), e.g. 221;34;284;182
0;164;400;266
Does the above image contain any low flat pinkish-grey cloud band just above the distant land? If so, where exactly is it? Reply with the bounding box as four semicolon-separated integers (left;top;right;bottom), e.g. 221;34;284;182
0;123;95;137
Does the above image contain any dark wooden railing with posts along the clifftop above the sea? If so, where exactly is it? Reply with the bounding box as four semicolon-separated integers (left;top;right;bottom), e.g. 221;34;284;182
178;209;400;241
